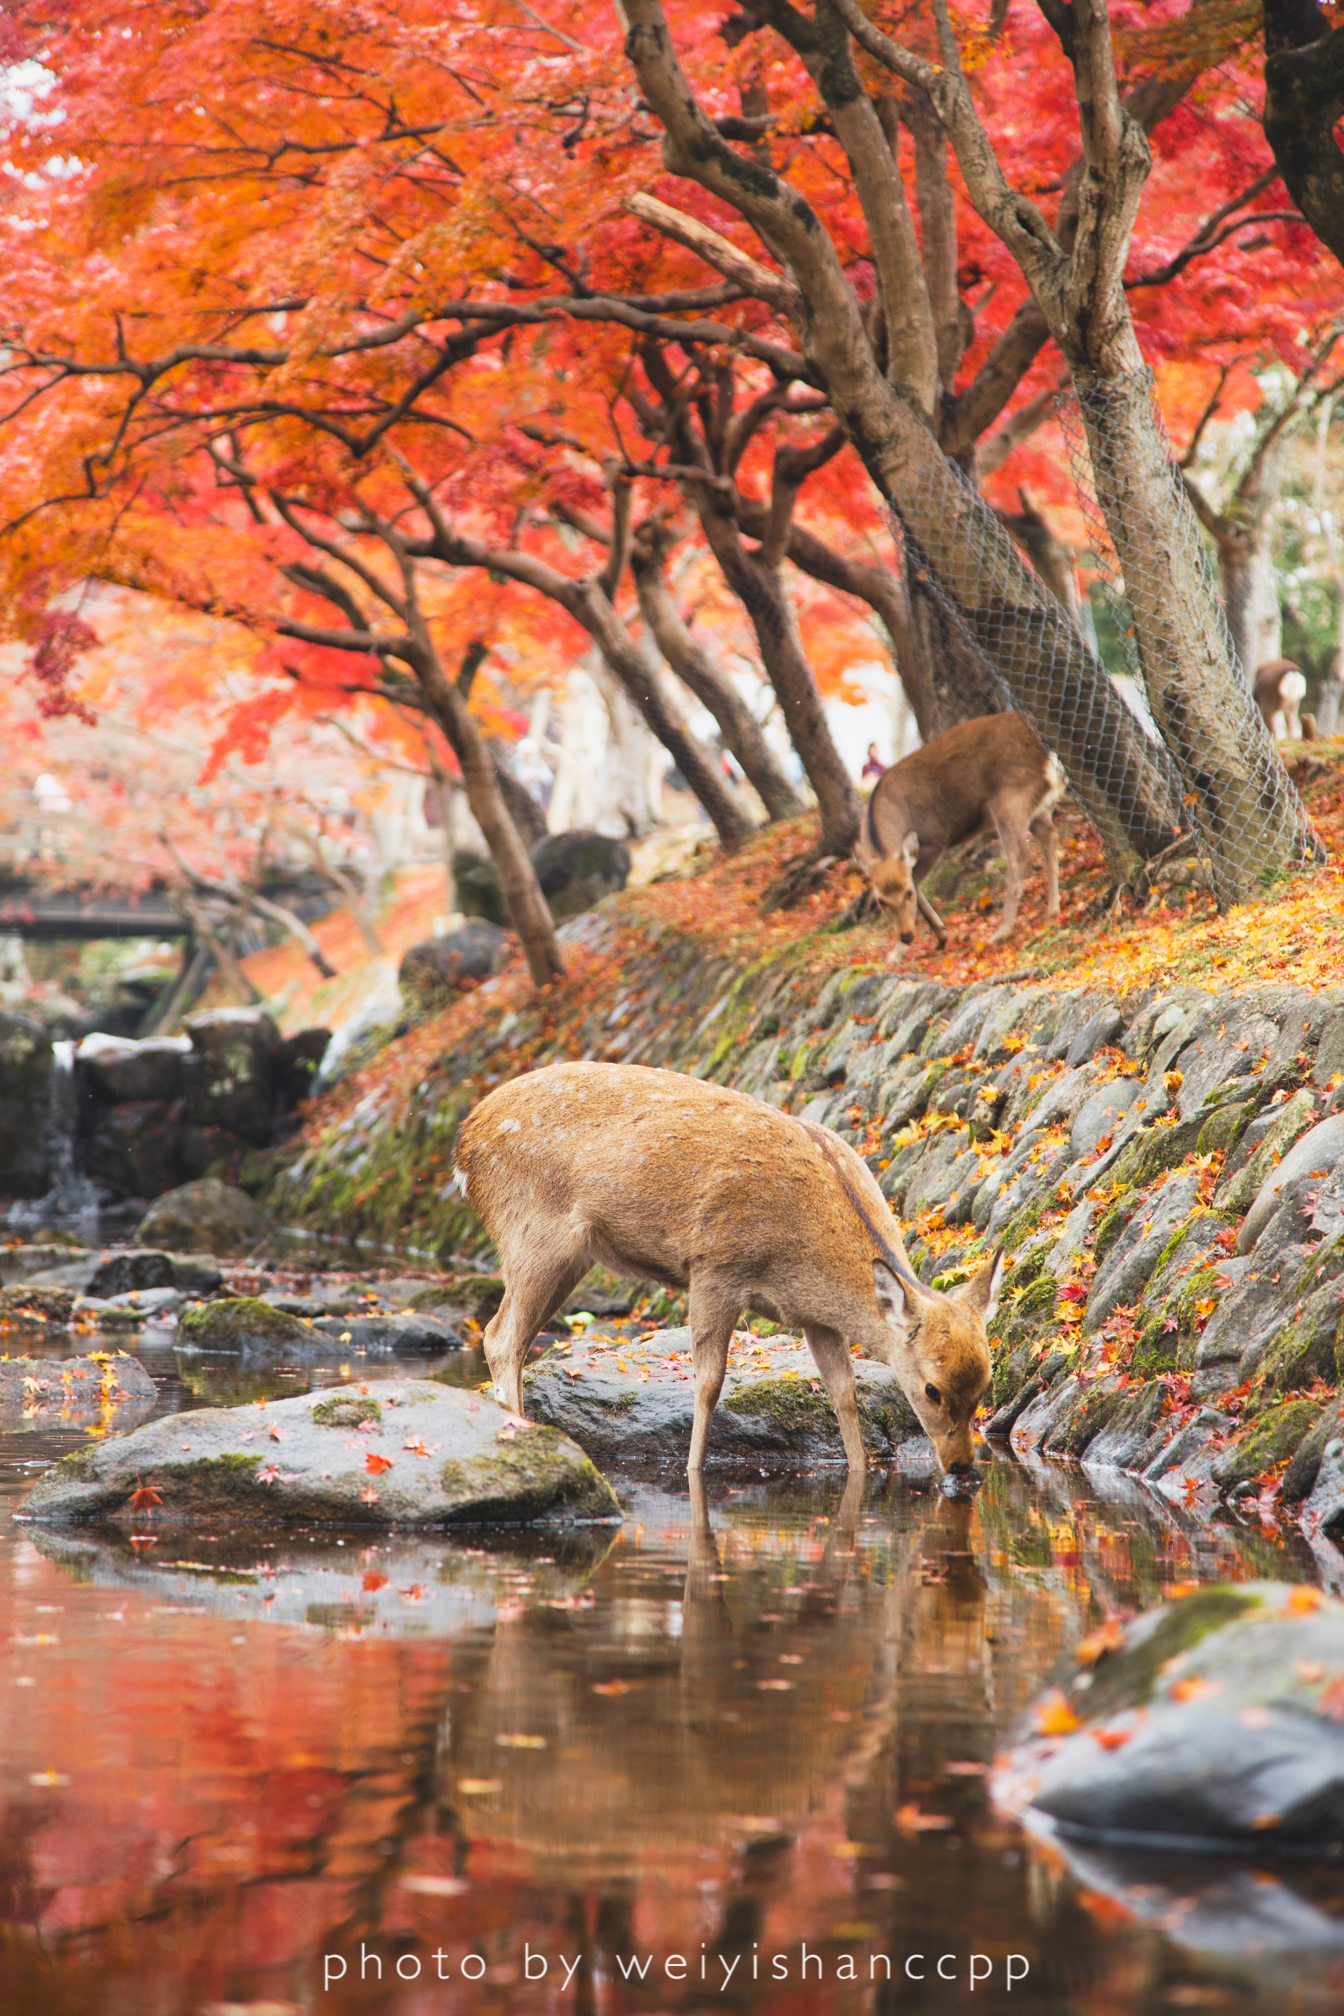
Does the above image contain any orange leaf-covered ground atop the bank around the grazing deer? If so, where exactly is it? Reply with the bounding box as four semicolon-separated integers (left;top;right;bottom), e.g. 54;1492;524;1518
259;738;1344;1153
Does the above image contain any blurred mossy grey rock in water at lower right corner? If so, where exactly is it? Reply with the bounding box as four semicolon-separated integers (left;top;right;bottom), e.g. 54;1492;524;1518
993;1583;1344;1857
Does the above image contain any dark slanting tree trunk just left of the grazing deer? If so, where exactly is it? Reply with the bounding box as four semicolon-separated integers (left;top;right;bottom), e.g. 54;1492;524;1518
695;501;862;859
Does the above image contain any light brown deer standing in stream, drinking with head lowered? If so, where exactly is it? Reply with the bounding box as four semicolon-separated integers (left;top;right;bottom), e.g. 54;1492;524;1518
455;1064;1003;1484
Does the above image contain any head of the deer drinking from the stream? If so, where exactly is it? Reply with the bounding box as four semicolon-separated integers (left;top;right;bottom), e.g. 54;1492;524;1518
872;1246;1003;1480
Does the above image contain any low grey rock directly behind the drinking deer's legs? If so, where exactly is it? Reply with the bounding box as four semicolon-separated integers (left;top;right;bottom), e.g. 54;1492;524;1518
524;1329;923;1464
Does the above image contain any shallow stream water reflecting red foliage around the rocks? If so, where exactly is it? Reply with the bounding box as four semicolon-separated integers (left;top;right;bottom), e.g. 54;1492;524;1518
0;1331;1344;2016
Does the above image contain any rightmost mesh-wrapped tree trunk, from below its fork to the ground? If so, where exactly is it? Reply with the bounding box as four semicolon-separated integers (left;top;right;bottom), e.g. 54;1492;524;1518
1074;371;1306;905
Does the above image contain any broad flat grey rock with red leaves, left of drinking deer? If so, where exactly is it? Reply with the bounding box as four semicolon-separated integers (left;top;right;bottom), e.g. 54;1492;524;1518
20;1379;621;1526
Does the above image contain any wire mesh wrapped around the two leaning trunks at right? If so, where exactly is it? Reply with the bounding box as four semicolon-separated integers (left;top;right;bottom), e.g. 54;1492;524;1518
891;373;1322;909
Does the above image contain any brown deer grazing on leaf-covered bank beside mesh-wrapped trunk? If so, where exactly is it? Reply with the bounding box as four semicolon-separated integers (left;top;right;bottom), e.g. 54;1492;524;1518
854;714;1064;950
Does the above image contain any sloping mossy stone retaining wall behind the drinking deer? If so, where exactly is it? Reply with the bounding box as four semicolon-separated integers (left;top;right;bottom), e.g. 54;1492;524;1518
266;909;1344;1536
